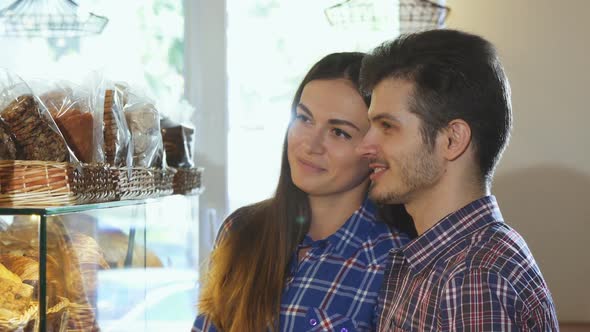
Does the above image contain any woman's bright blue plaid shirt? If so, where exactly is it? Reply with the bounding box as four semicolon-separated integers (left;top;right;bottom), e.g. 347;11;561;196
192;199;409;332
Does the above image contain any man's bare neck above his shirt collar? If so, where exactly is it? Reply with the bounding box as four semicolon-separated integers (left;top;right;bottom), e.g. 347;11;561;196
406;179;489;235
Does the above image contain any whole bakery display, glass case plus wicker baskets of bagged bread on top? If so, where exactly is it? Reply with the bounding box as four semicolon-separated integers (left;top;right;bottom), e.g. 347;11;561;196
0;69;203;332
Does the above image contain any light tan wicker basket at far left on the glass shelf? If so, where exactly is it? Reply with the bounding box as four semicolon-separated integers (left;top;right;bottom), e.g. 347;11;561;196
0;160;80;207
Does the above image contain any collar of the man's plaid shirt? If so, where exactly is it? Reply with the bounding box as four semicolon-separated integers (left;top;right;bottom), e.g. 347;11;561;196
402;196;504;273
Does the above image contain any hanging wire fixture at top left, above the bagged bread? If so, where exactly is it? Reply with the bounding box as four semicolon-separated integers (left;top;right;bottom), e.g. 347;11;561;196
0;0;109;37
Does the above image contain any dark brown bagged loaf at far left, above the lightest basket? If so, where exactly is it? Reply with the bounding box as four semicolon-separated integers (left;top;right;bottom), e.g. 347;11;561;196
0;95;68;162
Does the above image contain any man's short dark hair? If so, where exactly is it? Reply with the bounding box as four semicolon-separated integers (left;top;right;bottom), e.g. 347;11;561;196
361;29;512;184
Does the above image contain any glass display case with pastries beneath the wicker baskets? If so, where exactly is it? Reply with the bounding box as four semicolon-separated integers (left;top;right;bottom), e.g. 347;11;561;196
0;195;198;331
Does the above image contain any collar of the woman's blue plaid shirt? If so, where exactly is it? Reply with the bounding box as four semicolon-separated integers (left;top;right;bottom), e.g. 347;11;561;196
301;197;377;257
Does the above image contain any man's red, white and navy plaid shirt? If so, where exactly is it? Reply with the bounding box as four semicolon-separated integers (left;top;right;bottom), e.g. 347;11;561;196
378;196;559;331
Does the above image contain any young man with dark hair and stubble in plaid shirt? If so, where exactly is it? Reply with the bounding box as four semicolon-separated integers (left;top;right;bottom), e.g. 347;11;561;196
358;30;558;331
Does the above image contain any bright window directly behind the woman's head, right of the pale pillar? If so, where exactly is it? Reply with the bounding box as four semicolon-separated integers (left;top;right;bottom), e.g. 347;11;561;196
227;0;398;211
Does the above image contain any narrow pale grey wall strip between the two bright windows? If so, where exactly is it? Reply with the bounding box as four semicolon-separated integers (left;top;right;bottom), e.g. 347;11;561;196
184;0;228;272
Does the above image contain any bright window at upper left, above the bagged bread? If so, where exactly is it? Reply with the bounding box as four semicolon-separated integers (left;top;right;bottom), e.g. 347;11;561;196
0;0;184;102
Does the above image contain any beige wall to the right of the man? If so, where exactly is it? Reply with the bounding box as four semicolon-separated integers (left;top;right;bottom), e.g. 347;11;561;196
447;0;590;321
